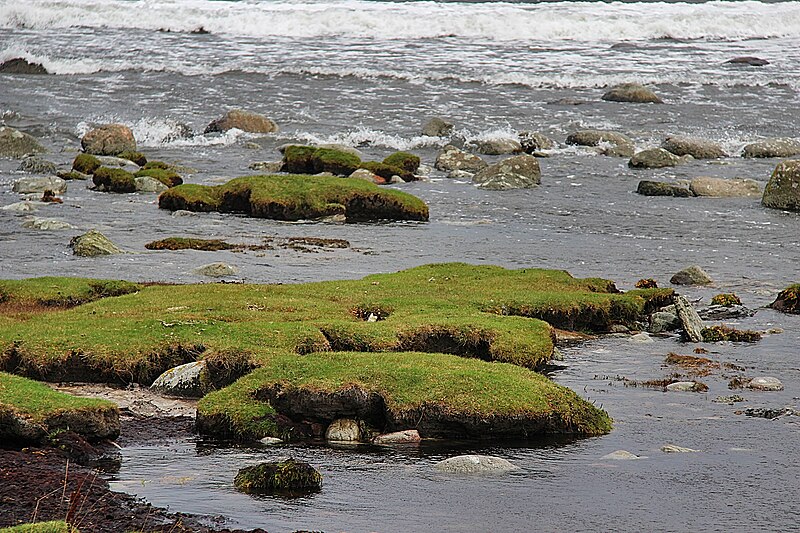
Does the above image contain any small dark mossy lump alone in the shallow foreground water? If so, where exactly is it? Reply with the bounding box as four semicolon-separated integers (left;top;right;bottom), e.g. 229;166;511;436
233;459;322;496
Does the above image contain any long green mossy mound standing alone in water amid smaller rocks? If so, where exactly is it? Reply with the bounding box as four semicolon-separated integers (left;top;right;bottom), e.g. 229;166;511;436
158;174;428;222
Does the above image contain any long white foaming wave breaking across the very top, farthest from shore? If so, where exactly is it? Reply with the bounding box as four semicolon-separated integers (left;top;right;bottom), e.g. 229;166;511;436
0;0;800;42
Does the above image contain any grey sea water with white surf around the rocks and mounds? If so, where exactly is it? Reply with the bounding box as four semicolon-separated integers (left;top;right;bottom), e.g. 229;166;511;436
0;0;800;532
